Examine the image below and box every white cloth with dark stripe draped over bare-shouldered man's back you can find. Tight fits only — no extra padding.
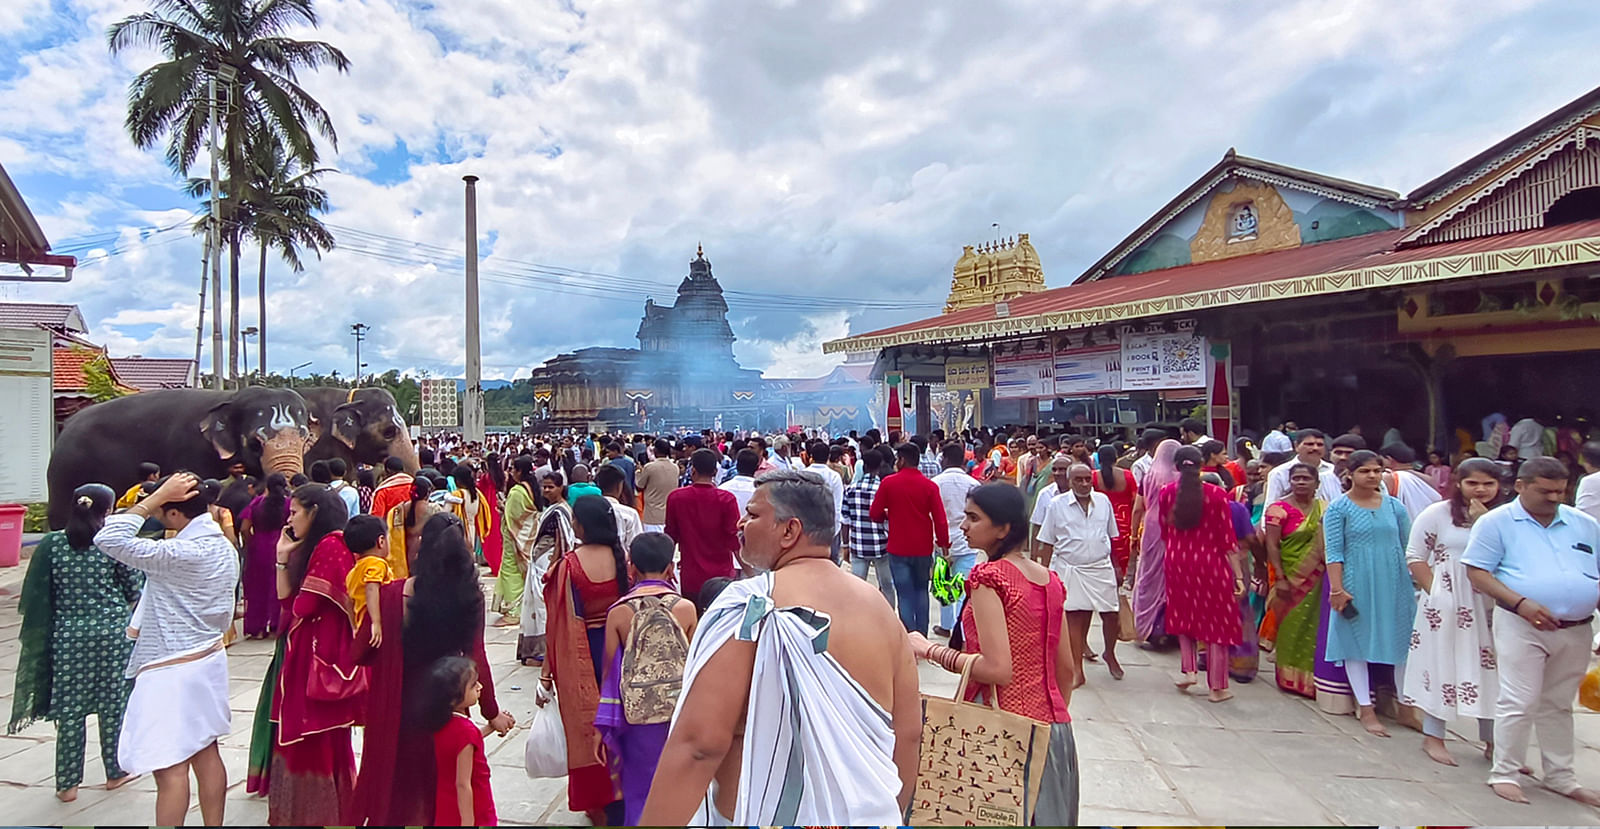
[672,573,904,826]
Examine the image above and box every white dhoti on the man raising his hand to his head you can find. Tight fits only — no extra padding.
[117,648,234,775]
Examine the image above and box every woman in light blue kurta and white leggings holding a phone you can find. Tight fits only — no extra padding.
[1323,450,1416,736]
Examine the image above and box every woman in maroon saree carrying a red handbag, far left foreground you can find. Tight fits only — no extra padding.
[267,483,366,826]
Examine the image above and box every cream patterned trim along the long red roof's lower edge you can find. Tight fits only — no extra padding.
[822,237,1600,354]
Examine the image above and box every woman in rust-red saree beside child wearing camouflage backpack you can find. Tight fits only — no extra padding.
[536,495,627,826]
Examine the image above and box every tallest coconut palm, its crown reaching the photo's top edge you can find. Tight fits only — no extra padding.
[107,0,350,388]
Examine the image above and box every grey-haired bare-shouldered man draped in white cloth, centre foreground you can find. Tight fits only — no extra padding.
[640,471,922,826]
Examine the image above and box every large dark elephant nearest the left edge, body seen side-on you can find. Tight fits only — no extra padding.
[46,386,314,530]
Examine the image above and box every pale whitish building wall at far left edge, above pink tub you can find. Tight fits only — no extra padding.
[0,328,56,504]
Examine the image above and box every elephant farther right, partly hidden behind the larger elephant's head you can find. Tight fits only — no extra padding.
[294,386,419,474]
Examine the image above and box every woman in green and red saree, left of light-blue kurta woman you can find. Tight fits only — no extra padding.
[1261,464,1326,699]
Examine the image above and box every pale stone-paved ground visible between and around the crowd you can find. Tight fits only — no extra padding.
[0,547,1600,826]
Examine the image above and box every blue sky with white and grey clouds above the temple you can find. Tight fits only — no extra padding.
[0,0,1600,384]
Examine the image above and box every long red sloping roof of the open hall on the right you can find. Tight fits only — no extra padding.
[834,219,1600,350]
